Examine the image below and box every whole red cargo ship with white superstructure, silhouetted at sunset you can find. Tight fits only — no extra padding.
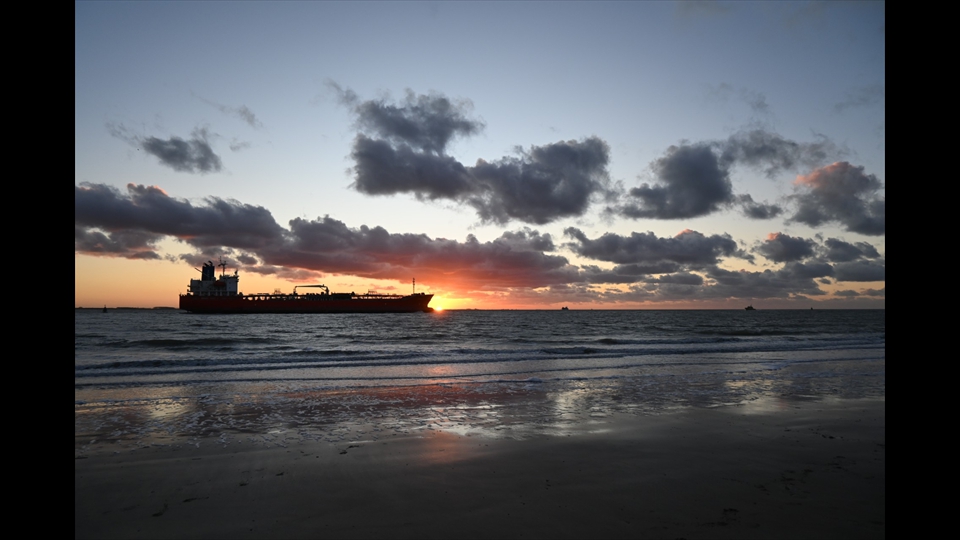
[180,260,433,313]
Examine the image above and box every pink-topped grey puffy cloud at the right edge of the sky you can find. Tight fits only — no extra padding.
[790,161,886,235]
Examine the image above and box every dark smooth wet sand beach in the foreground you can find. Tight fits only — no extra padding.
[74,400,886,539]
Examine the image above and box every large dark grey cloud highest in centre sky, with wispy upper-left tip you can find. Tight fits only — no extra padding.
[330,83,611,224]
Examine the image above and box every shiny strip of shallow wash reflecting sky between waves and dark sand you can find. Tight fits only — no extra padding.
[75,352,883,453]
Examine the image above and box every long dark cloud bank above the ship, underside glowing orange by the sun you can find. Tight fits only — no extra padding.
[74,184,580,290]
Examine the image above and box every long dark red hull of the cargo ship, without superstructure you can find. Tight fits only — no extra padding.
[180,294,433,313]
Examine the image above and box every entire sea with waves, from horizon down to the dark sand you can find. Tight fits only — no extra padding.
[74,309,886,455]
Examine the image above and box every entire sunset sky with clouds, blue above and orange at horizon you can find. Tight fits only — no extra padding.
[74,1,886,309]
